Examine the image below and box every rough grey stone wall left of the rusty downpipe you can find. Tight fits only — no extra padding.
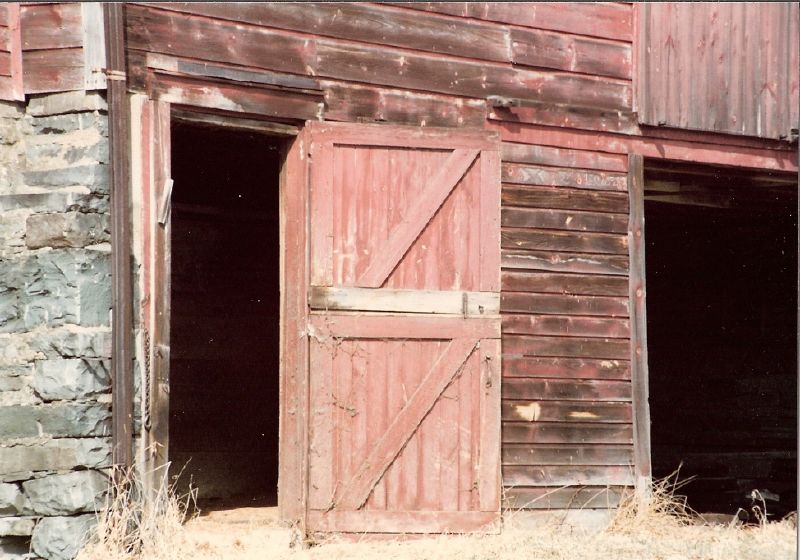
[0,92,111,560]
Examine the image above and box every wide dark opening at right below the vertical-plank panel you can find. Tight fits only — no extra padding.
[645,163,797,518]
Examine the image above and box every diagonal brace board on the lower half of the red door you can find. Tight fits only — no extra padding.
[334,338,480,510]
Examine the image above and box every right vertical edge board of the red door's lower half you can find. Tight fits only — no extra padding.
[478,339,501,511]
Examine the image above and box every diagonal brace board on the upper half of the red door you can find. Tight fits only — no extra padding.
[357,149,480,288]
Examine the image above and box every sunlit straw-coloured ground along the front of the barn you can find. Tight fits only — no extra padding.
[169,508,797,560]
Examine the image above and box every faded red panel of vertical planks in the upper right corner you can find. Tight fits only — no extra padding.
[637,2,800,138]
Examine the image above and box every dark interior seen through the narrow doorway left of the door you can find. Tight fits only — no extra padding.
[169,121,282,509]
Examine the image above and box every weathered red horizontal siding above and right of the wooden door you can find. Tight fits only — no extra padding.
[120,3,797,508]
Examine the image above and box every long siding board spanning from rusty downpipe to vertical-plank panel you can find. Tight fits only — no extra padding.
[128,6,632,110]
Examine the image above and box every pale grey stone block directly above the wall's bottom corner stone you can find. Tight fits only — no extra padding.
[22,470,108,515]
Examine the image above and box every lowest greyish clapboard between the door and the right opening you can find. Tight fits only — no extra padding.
[505,486,630,510]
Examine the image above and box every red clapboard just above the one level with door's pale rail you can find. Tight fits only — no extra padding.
[501,271,628,296]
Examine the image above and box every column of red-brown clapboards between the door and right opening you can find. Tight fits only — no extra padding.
[500,143,633,509]
